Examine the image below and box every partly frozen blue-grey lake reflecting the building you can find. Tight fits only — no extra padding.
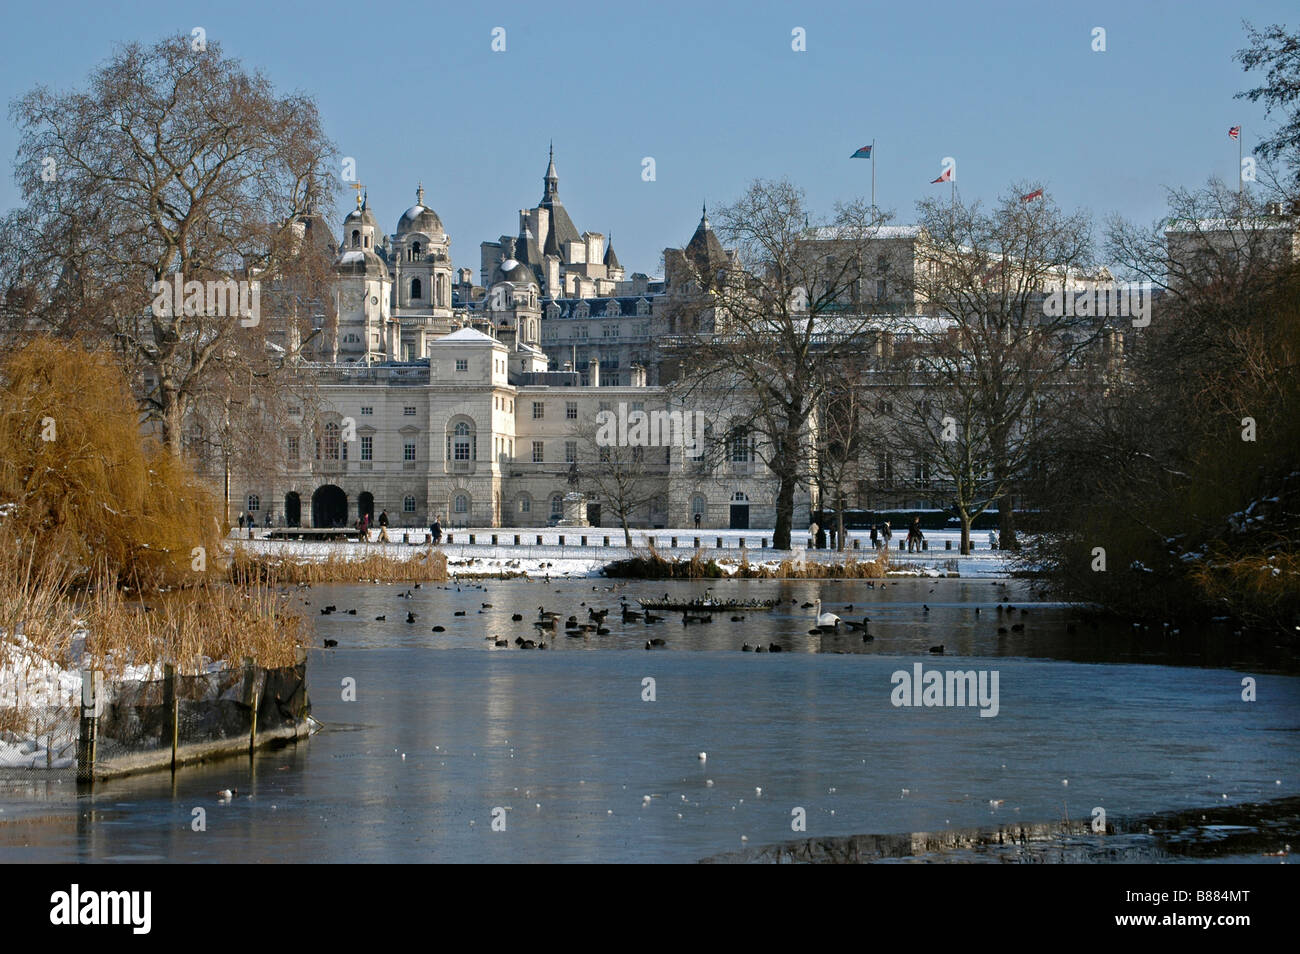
[0,580,1300,862]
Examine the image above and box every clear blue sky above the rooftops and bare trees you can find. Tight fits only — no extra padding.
[0,0,1300,276]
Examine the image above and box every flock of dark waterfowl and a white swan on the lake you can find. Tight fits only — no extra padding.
[304,581,1045,655]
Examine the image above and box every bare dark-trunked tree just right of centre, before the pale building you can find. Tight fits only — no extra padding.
[675,179,883,550]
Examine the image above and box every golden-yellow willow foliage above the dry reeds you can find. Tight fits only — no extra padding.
[0,338,221,589]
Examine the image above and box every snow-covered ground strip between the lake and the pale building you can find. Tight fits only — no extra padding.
[233,526,1010,577]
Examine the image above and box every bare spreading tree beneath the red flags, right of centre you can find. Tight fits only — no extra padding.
[897,186,1109,552]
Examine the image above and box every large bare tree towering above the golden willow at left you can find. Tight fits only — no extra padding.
[0,34,335,455]
